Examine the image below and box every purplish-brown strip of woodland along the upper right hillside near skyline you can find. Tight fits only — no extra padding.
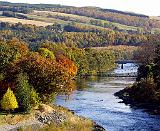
[53,7,160,29]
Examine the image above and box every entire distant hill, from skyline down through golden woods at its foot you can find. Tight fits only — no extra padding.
[0,2,160,49]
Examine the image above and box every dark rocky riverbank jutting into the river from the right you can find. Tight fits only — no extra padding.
[114,87,160,115]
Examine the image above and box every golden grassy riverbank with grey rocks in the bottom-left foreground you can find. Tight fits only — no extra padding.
[0,104,105,131]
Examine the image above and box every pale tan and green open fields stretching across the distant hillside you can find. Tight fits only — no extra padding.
[0,11,140,31]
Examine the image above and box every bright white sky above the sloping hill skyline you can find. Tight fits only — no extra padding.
[4,0,160,16]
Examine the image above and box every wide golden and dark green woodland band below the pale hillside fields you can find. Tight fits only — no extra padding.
[0,22,147,49]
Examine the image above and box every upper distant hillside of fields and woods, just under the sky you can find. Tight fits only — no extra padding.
[0,2,160,33]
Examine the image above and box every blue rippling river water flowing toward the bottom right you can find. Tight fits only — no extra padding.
[56,63,160,131]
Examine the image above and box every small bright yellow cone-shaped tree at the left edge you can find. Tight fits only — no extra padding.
[1,88,18,111]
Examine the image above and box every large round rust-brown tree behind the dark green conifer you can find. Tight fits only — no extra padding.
[17,52,68,94]
